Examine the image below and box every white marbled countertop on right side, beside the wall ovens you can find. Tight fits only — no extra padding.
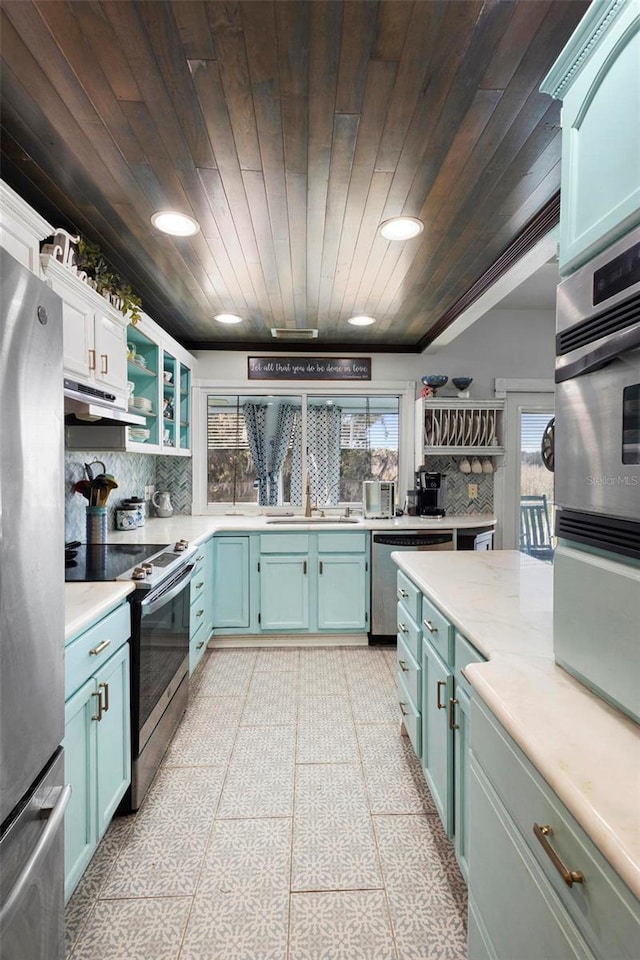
[392,550,640,897]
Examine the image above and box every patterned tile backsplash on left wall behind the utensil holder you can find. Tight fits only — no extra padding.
[64,450,191,543]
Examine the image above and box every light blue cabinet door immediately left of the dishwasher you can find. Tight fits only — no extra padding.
[318,553,368,630]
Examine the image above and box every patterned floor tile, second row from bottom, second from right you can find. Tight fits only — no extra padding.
[291,815,382,890]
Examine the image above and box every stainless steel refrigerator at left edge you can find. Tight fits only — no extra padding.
[0,250,70,960]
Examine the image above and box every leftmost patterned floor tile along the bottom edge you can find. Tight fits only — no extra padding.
[73,897,191,960]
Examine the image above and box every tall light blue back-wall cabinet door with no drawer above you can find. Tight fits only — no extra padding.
[211,535,251,630]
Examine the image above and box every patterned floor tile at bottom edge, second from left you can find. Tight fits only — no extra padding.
[178,887,289,960]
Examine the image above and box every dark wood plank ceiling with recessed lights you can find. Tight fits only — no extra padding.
[1,0,588,353]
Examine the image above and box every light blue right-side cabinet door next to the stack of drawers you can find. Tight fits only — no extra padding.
[422,639,453,837]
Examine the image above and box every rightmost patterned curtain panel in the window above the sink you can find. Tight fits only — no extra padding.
[307,406,342,506]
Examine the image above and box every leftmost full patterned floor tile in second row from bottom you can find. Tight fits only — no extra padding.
[100,820,209,899]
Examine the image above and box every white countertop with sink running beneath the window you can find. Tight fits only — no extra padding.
[104,513,496,543]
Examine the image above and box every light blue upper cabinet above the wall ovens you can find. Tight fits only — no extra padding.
[540,0,640,276]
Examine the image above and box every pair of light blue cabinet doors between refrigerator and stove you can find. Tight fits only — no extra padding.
[63,638,131,900]
